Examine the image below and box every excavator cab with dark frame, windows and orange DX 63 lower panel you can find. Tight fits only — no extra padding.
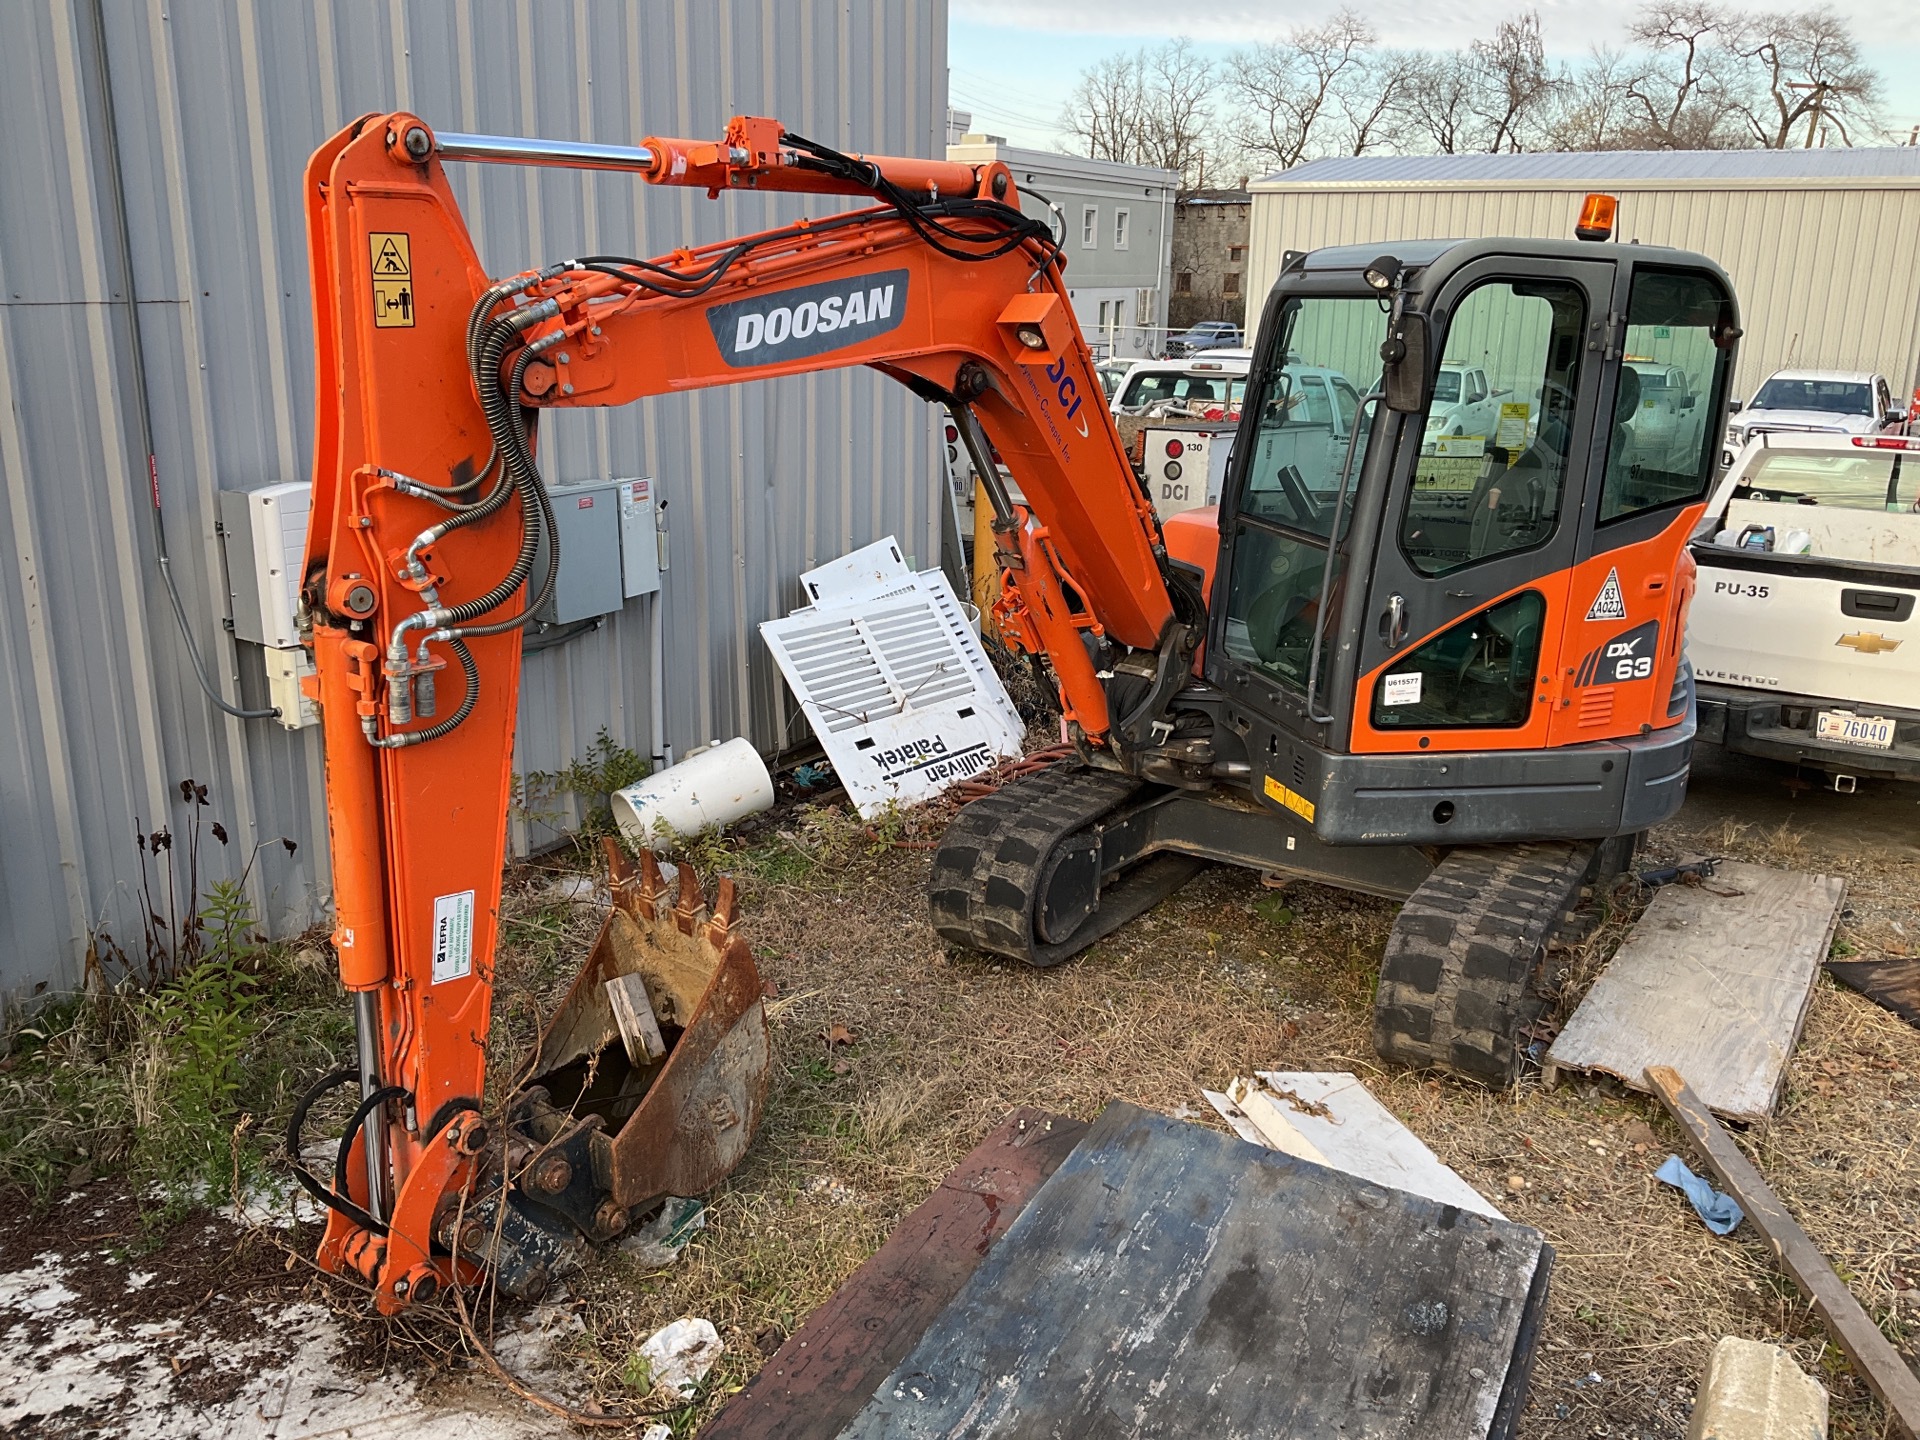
[1205,240,1738,847]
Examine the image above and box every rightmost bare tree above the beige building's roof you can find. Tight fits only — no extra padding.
[1732,6,1880,150]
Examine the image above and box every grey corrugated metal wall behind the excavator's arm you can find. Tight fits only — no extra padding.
[0,0,947,995]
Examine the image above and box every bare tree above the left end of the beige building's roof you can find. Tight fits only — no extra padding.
[1227,10,1375,169]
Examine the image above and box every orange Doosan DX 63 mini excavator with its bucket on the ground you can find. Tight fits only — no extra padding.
[290,113,1740,1309]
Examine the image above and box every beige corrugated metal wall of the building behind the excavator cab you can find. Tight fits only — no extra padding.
[1250,177,1920,407]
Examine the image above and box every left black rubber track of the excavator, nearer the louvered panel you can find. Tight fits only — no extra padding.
[927,764,1206,966]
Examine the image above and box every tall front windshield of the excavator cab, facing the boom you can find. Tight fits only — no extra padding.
[1225,296,1386,691]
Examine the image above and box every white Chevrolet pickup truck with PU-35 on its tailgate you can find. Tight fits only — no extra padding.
[1686,432,1920,793]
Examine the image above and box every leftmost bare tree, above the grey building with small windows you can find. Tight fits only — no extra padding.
[1060,38,1215,186]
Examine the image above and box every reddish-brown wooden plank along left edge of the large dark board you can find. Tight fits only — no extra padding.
[701,1108,1087,1440]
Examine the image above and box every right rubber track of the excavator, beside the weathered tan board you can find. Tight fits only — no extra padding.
[1373,841,1594,1085]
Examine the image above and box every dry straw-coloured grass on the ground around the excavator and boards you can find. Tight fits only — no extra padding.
[483,794,1920,1436]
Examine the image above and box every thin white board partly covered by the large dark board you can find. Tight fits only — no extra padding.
[1258,1069,1505,1219]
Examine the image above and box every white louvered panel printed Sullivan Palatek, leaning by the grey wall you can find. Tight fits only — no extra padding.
[760,570,1021,818]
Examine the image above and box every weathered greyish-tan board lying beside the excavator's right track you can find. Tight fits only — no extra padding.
[1546,860,1847,1119]
